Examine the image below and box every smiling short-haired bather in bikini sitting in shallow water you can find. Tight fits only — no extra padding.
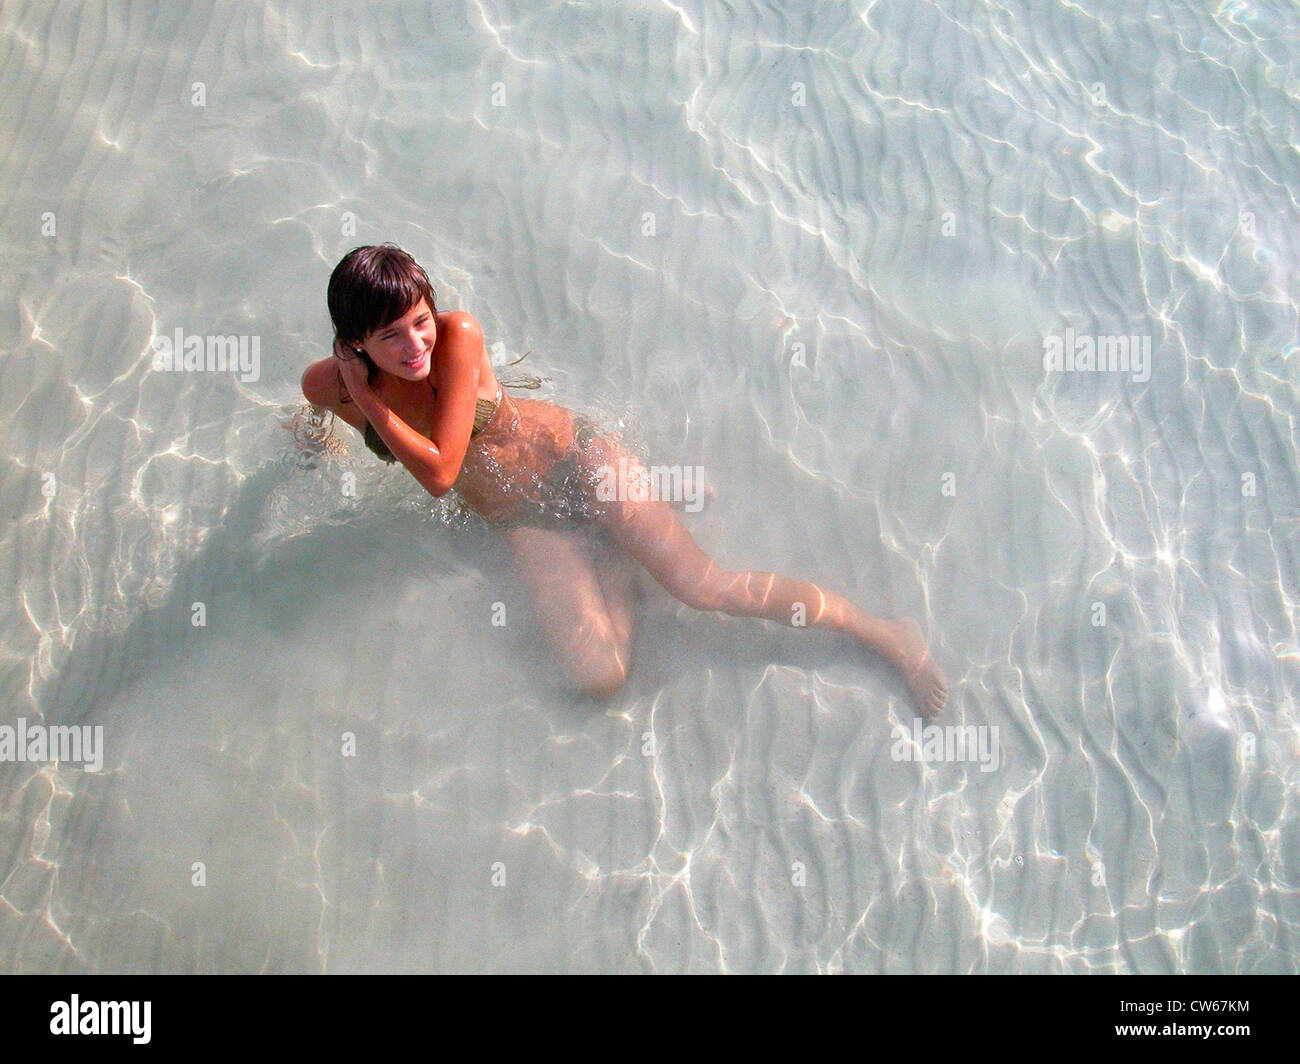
[303,245,948,717]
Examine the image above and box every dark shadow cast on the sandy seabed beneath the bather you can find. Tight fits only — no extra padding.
[38,439,905,727]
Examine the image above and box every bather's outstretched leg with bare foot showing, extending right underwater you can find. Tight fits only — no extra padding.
[603,465,948,717]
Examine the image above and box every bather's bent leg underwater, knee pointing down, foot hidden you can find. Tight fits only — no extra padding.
[506,528,633,698]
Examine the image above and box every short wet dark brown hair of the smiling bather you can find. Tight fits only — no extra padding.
[326,243,438,381]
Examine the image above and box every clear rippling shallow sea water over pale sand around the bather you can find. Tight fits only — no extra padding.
[0,0,1300,973]
